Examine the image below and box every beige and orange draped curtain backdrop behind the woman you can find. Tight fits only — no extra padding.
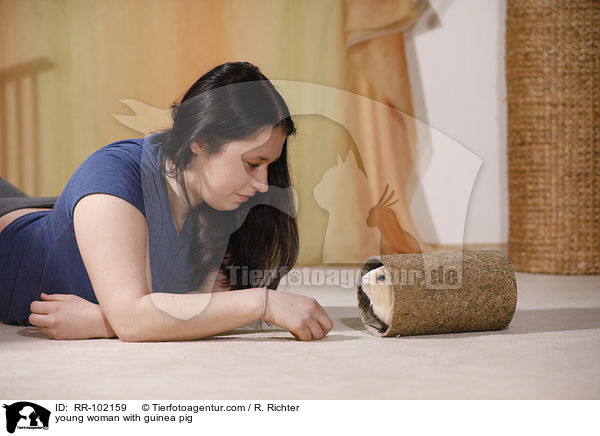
[0,0,422,265]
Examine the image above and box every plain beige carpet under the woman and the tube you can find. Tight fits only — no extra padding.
[0,266,600,399]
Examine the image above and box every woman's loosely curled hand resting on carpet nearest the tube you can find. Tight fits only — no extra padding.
[264,289,333,341]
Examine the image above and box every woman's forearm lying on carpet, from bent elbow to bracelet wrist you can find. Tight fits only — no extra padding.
[120,288,265,342]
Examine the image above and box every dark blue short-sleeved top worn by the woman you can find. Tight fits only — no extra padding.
[0,135,200,325]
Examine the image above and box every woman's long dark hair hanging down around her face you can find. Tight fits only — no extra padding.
[153,62,299,290]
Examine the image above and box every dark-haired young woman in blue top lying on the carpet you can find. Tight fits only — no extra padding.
[0,62,333,341]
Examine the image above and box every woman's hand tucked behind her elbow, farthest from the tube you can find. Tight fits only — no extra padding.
[29,293,116,339]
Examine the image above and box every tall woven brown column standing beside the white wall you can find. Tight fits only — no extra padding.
[505,0,600,274]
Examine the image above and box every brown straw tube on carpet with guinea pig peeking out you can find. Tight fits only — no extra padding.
[357,250,517,337]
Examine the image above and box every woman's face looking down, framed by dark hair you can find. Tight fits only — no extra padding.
[186,126,286,210]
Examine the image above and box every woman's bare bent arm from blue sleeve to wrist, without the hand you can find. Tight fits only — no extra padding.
[73,194,265,341]
